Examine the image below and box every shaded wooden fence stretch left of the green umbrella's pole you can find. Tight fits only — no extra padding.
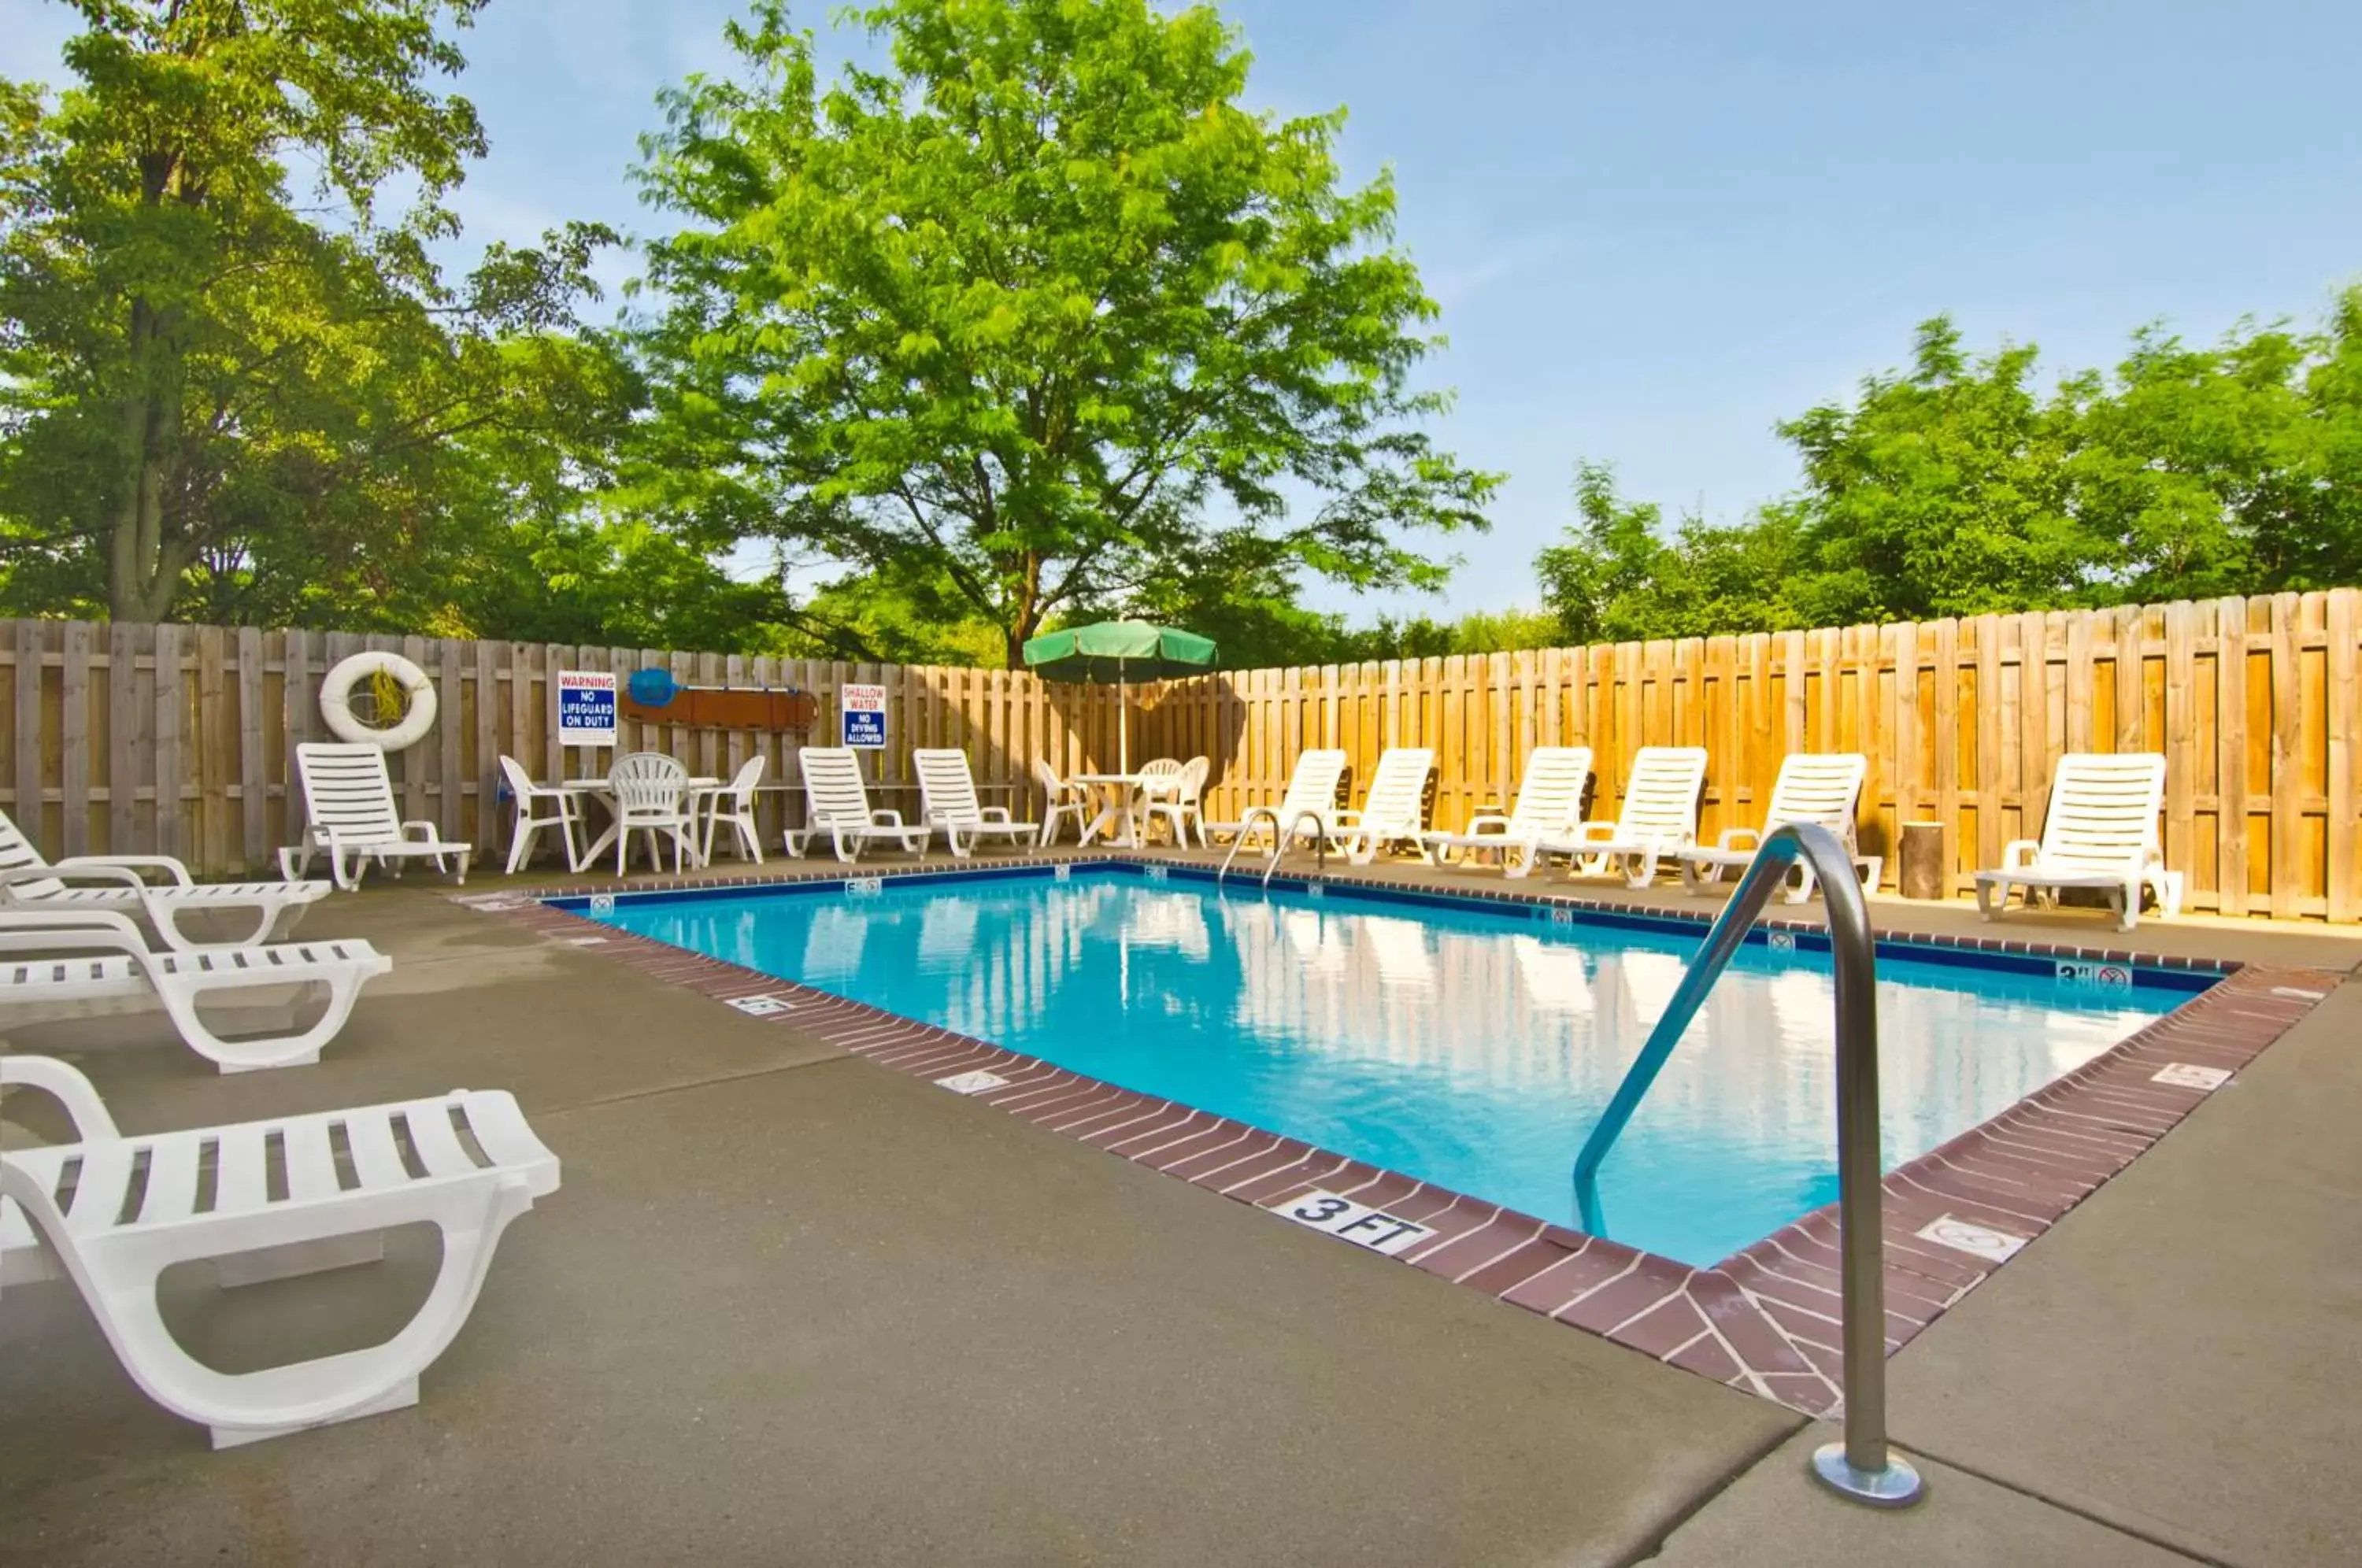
[0,621,1138,876]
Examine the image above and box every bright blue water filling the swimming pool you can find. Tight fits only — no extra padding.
[595,869,2187,1266]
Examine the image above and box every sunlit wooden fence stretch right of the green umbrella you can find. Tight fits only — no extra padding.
[1131,588,2362,921]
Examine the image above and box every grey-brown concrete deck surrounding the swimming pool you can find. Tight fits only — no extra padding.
[0,850,2362,1563]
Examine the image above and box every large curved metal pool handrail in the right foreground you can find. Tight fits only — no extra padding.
[1575,822,1925,1509]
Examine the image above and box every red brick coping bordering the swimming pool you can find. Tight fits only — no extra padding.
[454,855,2343,1415]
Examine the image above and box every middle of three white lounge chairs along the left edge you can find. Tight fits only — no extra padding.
[0,909,394,1072]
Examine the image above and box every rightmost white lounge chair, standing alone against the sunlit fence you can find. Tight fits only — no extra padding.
[1977,751,2182,930]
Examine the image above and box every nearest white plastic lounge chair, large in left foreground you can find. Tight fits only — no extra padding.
[0,1056,557,1448]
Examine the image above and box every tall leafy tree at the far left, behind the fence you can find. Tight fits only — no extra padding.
[0,0,621,623]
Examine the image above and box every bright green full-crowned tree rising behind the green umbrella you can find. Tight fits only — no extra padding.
[640,0,1495,664]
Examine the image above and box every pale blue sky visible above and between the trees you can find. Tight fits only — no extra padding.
[0,0,2362,614]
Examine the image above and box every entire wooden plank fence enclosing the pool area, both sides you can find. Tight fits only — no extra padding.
[0,590,2362,921]
